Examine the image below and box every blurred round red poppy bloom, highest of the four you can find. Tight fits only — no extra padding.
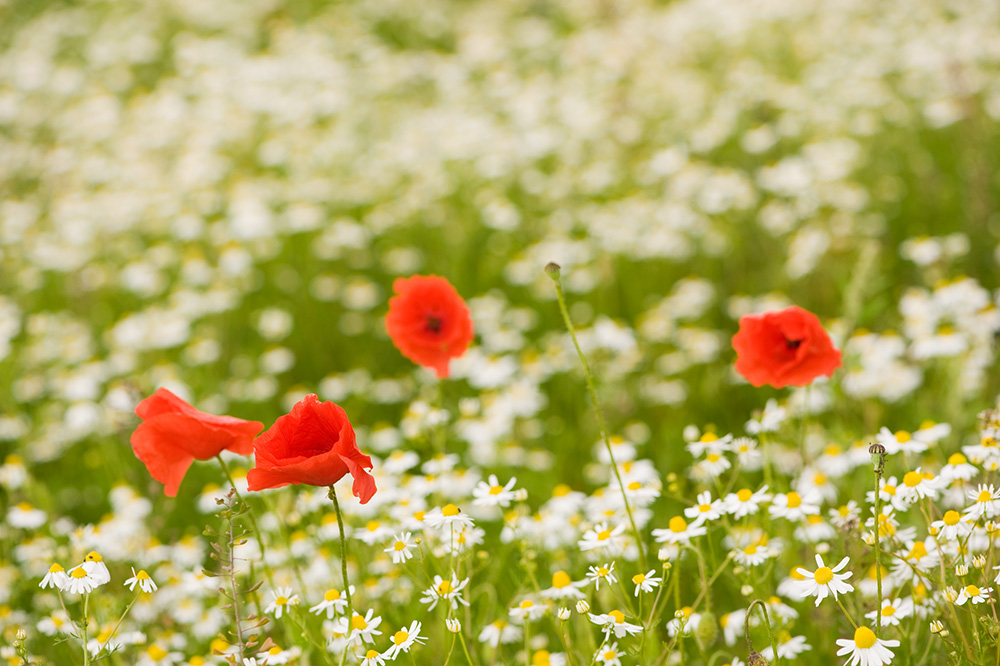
[385,275,472,379]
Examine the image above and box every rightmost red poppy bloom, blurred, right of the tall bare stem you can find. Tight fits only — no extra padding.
[733,306,841,388]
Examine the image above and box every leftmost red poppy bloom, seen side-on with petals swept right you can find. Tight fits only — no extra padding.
[131,388,264,497]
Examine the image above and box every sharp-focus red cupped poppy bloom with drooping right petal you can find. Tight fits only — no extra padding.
[247,393,375,504]
